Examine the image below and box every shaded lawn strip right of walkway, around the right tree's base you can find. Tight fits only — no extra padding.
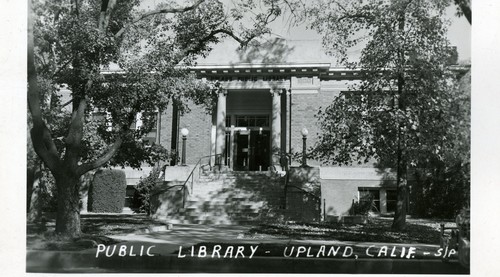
[249,218,440,244]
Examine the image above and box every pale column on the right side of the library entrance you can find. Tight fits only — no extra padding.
[271,88,283,166]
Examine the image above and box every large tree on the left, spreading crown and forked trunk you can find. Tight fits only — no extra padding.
[28,0,290,237]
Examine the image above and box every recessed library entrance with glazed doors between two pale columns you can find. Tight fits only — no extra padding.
[212,86,286,171]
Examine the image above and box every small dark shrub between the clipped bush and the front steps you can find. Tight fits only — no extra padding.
[132,166,165,215]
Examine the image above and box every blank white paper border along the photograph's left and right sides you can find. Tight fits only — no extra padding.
[0,0,500,276]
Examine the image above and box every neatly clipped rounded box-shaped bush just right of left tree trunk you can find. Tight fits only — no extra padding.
[88,169,127,213]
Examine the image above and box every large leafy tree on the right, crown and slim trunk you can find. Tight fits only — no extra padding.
[309,0,469,230]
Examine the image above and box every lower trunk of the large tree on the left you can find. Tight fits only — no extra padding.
[55,175,81,238]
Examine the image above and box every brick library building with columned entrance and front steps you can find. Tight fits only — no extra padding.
[109,38,464,222]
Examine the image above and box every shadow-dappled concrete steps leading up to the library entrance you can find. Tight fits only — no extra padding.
[162,169,283,225]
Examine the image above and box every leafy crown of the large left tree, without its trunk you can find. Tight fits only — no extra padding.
[33,0,292,170]
